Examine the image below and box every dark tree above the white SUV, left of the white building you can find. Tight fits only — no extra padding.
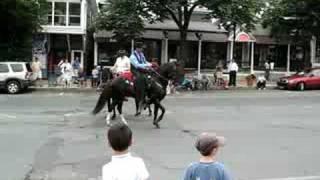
[0,0,47,61]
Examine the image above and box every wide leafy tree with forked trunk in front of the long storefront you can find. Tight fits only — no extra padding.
[97,0,262,60]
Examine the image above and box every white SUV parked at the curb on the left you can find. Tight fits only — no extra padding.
[0,62,34,94]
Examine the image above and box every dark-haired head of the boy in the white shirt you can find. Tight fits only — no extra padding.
[108,123,132,151]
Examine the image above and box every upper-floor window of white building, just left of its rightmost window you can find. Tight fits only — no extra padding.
[54,2,67,26]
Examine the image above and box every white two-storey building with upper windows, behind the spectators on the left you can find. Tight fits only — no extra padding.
[33,0,89,78]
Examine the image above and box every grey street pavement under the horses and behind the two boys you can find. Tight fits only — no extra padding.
[0,90,320,180]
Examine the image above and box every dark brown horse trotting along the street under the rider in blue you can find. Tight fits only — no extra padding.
[92,63,177,127]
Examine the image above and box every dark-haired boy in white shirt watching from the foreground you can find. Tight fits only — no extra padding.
[102,123,149,180]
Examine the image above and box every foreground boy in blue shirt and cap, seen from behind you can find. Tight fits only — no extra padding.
[183,133,232,180]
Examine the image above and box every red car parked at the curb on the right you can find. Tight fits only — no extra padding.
[277,68,320,91]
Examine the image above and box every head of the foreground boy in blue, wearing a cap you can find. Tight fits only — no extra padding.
[195,133,225,156]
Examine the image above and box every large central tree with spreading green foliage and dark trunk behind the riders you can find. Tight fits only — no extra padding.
[95,0,260,59]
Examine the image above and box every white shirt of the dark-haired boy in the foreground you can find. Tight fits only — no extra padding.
[102,153,149,180]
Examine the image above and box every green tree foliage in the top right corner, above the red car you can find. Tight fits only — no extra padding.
[264,0,320,41]
